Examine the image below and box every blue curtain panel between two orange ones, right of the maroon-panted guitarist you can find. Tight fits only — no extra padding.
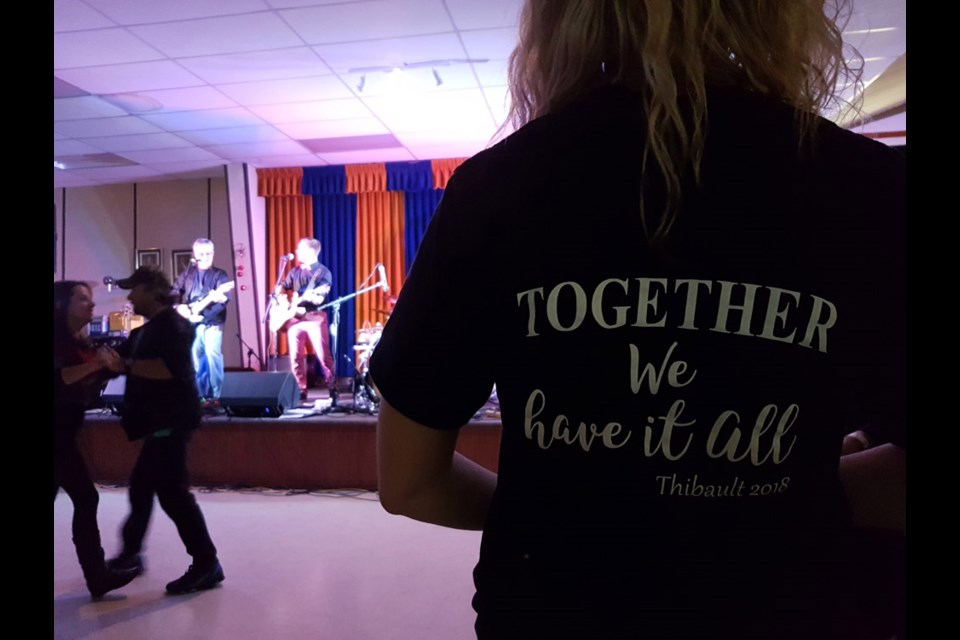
[314,192,357,377]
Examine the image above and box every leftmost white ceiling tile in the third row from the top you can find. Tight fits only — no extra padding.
[57,60,203,93]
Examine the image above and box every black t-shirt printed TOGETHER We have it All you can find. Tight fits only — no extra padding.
[371,88,906,637]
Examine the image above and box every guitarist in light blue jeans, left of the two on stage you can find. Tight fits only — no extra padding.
[171,238,234,408]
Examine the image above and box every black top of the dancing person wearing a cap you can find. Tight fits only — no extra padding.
[118,307,200,440]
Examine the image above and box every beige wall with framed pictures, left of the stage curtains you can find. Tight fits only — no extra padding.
[53,178,244,367]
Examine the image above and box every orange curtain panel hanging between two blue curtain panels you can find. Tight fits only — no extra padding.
[356,191,405,336]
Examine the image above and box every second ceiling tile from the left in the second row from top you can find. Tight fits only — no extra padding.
[130,13,303,58]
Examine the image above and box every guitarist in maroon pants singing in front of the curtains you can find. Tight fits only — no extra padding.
[270,238,336,400]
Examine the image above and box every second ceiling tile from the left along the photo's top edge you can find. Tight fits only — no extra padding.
[87,0,269,24]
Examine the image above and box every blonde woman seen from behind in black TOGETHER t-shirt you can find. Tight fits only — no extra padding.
[370,0,906,639]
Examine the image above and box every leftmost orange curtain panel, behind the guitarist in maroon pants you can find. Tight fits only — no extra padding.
[257,168,313,354]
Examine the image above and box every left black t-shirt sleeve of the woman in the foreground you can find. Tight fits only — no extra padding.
[370,167,494,429]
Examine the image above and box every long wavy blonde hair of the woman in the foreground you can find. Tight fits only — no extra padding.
[508,0,860,242]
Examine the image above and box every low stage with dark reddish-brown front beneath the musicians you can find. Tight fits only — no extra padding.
[79,391,501,490]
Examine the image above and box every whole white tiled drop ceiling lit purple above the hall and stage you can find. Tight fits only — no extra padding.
[53,0,906,187]
